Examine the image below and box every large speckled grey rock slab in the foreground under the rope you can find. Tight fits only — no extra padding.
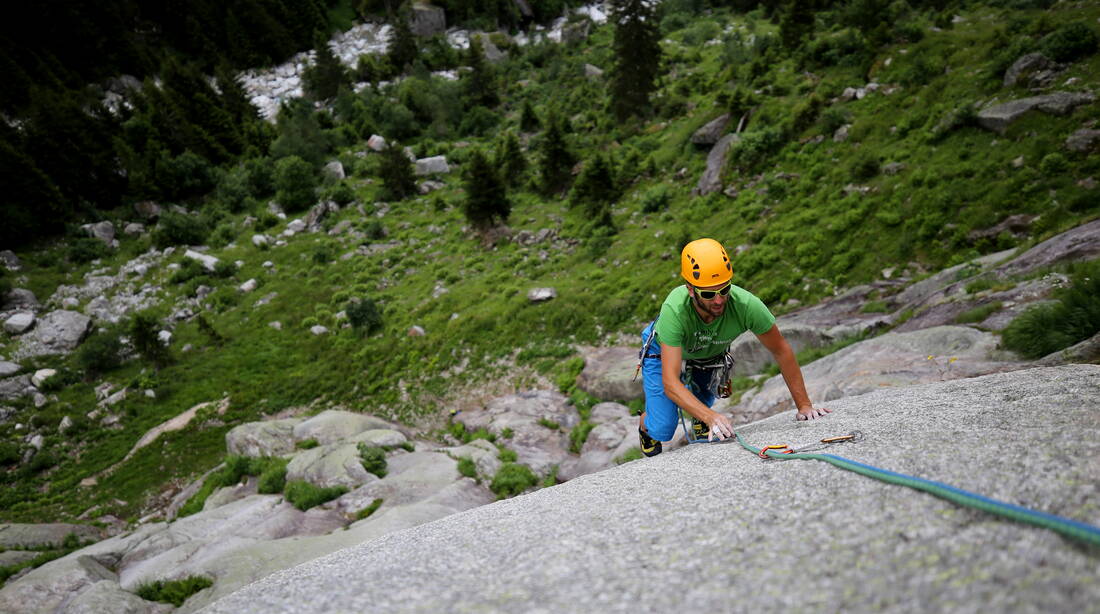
[198,365,1100,614]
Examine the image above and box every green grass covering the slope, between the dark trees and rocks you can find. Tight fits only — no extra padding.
[0,4,1100,520]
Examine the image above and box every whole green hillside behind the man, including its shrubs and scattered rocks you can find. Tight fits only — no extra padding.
[0,2,1100,554]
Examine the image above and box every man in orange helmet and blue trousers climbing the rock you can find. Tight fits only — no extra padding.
[638,239,829,457]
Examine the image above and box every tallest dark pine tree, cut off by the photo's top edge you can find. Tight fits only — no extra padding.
[611,0,661,120]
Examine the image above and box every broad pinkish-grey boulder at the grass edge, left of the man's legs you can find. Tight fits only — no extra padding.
[454,391,581,475]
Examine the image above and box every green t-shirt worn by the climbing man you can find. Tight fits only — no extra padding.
[657,286,776,359]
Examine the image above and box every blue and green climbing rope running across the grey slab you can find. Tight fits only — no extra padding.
[734,431,1100,546]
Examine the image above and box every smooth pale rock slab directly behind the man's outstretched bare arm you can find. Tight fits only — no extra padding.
[735,326,1021,423]
